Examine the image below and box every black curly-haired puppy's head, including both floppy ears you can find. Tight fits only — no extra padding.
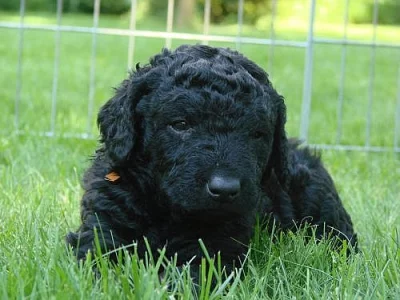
[98,45,288,215]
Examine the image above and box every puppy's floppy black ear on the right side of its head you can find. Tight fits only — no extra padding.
[266,92,290,190]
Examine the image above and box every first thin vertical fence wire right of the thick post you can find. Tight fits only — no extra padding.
[336,0,349,145]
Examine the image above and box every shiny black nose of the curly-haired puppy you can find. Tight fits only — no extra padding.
[207,175,240,202]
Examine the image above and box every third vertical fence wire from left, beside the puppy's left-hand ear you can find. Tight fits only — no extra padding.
[86,0,100,136]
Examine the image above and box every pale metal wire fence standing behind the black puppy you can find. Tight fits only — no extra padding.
[0,0,400,152]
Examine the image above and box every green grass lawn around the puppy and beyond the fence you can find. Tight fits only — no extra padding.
[0,10,400,299]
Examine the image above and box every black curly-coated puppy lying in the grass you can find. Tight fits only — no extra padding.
[67,45,356,274]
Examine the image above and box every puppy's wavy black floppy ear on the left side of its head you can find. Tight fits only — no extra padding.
[97,80,136,164]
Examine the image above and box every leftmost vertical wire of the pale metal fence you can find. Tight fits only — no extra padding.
[14,0,25,131]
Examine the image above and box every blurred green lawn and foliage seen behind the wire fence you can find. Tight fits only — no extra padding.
[0,0,400,147]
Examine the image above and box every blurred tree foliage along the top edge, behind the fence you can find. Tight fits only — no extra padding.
[0,0,400,27]
